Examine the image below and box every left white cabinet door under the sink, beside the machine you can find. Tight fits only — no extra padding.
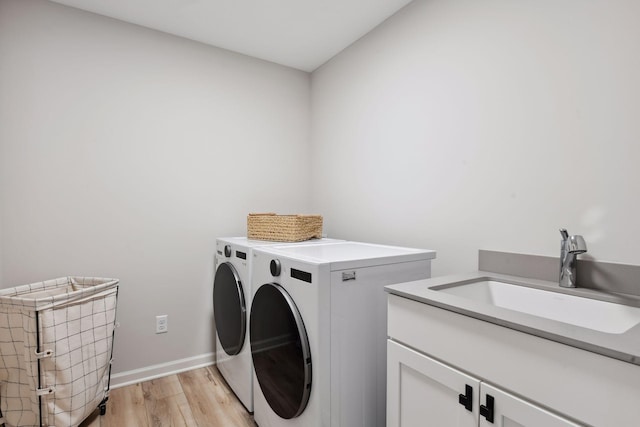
[387,340,480,427]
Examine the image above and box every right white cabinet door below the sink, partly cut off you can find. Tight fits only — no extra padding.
[479,383,580,427]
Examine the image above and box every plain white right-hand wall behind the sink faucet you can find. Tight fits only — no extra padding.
[311,0,640,275]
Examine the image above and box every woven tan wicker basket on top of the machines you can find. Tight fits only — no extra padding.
[247,213,322,242]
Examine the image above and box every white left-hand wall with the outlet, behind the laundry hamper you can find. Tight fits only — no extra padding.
[0,0,310,374]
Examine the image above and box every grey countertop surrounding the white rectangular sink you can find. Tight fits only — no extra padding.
[385,271,640,365]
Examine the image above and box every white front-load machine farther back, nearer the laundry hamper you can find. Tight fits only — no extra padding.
[213,237,343,412]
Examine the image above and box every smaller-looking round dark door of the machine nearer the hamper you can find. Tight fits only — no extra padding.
[213,262,247,356]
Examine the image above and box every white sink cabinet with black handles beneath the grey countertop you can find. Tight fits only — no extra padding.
[387,295,640,427]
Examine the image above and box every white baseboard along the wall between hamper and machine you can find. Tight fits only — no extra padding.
[110,353,215,389]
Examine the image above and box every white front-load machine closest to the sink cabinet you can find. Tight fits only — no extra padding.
[249,242,436,427]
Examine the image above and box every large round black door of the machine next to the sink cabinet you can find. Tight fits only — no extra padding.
[249,283,311,419]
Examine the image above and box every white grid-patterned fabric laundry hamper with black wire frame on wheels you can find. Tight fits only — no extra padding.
[0,277,119,427]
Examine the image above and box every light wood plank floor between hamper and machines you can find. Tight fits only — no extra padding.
[80,366,256,427]
